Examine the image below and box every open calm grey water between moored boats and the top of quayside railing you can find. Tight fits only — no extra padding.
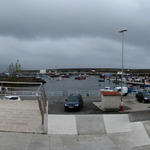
[44,76,123,95]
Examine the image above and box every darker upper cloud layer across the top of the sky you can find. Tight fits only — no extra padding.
[0,0,150,38]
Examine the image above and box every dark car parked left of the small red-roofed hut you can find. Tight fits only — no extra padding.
[64,94,83,111]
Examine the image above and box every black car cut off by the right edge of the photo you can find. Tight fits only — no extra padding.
[136,91,150,103]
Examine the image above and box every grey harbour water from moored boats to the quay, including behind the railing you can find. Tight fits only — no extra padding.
[44,76,128,96]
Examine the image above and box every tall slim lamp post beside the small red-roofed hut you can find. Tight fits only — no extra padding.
[119,29,127,109]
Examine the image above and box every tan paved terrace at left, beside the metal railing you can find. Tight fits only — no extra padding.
[0,100,43,133]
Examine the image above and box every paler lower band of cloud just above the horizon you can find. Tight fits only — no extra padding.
[0,37,150,69]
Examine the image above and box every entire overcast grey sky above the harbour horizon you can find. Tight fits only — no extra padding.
[0,0,150,69]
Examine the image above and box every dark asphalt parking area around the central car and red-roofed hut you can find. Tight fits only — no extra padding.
[48,96,150,114]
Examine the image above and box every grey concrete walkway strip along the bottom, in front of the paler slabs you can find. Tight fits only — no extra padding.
[0,132,150,150]
